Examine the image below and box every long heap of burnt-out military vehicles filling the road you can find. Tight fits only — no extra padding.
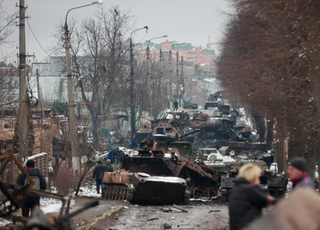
[98,99,287,204]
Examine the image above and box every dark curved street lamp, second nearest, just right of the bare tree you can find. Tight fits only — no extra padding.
[130,26,148,139]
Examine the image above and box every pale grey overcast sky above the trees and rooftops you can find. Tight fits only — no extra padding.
[1,0,232,61]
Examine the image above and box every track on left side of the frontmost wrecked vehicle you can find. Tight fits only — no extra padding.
[101,186,133,201]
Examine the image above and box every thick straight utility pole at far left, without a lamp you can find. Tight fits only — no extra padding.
[18,0,28,160]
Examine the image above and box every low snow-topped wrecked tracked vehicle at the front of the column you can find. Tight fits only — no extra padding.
[101,170,190,204]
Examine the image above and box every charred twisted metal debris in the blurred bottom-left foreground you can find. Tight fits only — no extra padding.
[0,153,99,230]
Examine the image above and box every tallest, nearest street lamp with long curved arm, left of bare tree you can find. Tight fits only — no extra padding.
[64,0,103,173]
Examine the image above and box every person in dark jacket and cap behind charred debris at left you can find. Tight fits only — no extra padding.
[17,160,47,217]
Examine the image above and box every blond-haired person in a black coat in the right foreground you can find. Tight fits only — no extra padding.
[229,164,274,230]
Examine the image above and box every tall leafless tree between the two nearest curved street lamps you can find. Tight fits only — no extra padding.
[73,7,130,149]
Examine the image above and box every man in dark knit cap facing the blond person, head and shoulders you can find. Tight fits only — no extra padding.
[287,157,315,189]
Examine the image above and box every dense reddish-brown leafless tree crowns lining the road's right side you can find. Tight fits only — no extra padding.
[218,0,320,180]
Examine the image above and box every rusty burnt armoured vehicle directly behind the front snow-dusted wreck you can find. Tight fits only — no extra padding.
[122,134,219,197]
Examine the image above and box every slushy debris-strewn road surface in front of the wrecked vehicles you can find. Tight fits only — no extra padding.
[63,197,229,230]
